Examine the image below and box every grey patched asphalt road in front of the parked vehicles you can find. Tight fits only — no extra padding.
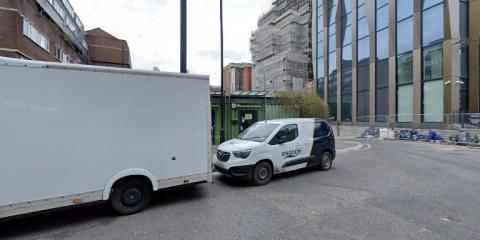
[0,141,480,240]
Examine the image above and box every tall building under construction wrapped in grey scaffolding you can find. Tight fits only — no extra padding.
[250,0,313,91]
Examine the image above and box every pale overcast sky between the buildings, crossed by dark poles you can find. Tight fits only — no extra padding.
[70,0,272,86]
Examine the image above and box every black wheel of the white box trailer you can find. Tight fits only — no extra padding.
[110,179,152,215]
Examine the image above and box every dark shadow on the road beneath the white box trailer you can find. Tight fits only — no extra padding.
[0,185,206,239]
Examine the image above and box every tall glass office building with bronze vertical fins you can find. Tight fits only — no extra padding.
[312,0,480,123]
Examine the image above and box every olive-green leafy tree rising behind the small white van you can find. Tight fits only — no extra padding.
[277,91,330,119]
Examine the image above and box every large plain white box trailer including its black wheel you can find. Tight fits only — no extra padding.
[0,58,212,219]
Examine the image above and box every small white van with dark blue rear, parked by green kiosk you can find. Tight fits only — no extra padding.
[214,119,335,185]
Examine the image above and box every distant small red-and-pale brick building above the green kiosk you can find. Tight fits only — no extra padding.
[223,63,252,95]
